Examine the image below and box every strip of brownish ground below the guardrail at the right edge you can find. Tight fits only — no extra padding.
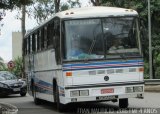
[144,85,160,92]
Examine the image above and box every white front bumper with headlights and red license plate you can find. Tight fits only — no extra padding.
[62,83,144,104]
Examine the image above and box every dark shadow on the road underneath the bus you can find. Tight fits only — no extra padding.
[20,101,119,114]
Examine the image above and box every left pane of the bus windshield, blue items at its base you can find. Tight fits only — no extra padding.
[64,19,104,60]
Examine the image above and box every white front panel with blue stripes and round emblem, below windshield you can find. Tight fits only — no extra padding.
[63,60,143,85]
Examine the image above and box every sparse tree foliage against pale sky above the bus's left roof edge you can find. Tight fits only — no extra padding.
[30,0,81,24]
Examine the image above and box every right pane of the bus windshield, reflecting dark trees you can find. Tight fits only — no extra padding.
[103,17,140,58]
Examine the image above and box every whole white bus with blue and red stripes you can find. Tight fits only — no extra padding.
[23,7,144,110]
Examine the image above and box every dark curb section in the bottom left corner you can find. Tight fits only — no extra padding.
[0,102,18,114]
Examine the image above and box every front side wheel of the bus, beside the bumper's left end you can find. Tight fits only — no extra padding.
[55,85,64,112]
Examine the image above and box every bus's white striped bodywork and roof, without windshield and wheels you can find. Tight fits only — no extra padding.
[23,7,144,108]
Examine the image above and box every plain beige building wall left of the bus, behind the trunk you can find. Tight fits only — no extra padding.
[12,32,22,60]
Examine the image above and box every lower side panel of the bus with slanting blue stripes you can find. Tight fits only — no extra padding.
[26,49,63,102]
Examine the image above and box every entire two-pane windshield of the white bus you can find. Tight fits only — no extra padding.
[64,17,140,61]
